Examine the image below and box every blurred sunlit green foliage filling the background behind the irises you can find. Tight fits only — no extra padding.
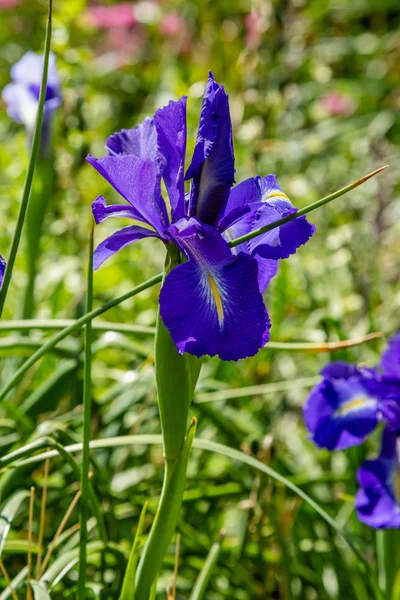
[0,0,400,600]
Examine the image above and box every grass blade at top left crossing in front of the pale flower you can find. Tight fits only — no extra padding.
[0,0,53,318]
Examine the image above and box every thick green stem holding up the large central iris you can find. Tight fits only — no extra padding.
[135,245,201,600]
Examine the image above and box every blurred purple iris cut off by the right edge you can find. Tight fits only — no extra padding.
[304,332,400,528]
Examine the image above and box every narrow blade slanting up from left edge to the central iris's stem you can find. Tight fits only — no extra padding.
[0,273,162,402]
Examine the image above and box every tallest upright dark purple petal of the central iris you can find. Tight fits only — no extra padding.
[185,73,235,224]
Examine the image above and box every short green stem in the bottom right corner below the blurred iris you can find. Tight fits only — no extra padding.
[377,529,400,600]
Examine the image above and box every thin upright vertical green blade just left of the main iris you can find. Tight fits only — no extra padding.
[78,225,93,600]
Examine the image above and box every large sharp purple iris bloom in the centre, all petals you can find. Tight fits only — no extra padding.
[87,73,315,360]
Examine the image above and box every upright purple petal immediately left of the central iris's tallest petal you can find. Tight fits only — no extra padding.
[154,96,187,221]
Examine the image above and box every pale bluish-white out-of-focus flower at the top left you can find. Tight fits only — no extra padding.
[2,52,61,148]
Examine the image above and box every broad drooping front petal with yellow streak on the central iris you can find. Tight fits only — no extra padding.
[160,218,270,360]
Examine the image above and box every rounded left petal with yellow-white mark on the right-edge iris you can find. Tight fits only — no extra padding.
[304,363,378,450]
